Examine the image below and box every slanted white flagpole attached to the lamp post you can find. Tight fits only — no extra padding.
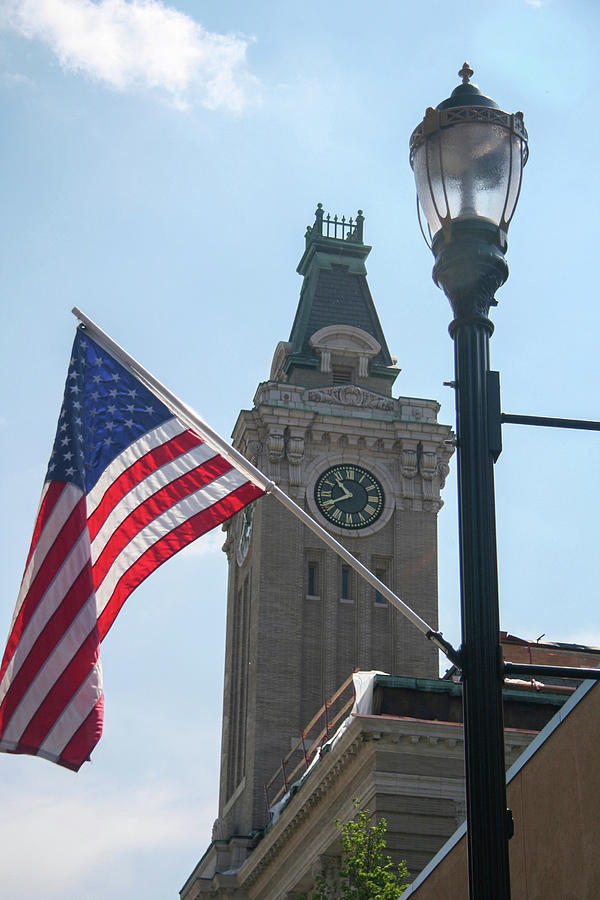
[71,306,460,665]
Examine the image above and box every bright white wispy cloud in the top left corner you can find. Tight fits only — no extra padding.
[0,0,258,112]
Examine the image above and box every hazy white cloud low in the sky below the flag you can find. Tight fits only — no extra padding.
[0,776,214,900]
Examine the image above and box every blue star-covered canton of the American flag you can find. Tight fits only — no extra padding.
[46,331,173,494]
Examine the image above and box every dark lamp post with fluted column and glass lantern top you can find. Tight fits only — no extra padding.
[410,63,528,900]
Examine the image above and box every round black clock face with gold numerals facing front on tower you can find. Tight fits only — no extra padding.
[315,464,385,530]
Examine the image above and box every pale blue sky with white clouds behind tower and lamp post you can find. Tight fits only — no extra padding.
[0,0,600,900]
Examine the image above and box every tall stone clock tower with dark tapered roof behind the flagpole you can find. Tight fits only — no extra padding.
[213,204,452,852]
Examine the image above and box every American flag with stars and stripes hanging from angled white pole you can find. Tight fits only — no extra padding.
[0,330,264,771]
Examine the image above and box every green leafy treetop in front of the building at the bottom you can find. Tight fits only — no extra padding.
[311,800,408,900]
